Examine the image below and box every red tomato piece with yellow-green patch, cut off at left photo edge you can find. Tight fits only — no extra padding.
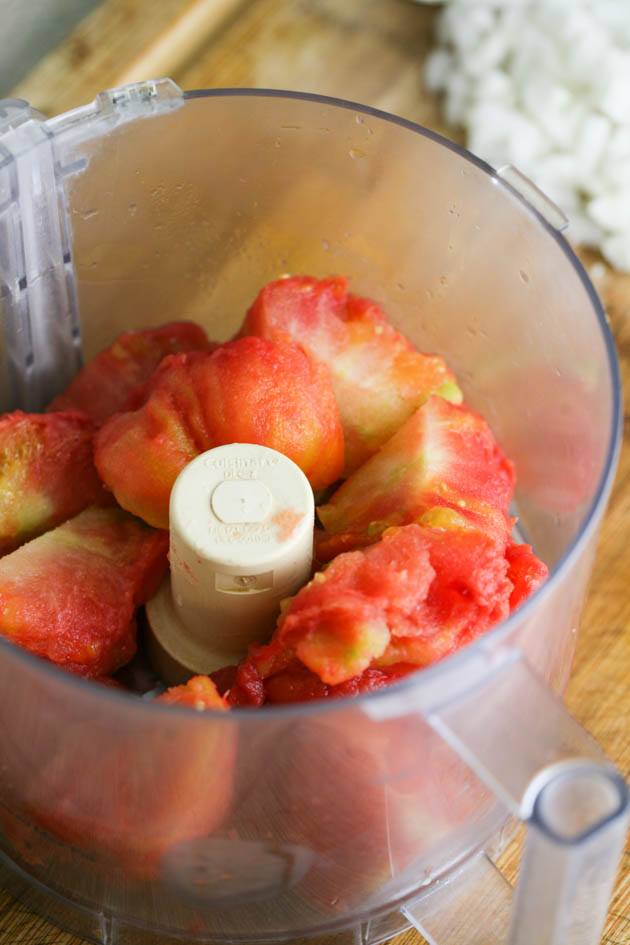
[0,410,111,555]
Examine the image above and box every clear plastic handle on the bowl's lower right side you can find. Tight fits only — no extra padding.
[403,654,629,945]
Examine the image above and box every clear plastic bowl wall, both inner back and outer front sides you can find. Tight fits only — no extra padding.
[0,93,616,943]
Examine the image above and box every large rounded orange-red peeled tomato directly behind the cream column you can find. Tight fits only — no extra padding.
[95,338,343,528]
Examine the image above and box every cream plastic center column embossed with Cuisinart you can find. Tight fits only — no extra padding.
[146,443,315,685]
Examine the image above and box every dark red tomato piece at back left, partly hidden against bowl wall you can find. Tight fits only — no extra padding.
[48,322,214,426]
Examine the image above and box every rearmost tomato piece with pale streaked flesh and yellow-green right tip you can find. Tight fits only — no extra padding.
[241,276,462,475]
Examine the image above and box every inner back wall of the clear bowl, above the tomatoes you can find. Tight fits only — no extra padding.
[66,95,611,559]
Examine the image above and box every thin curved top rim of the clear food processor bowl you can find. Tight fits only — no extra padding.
[0,88,623,724]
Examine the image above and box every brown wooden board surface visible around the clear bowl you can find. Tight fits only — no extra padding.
[0,0,630,945]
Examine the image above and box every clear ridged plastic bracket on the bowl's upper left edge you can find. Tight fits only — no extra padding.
[0,79,184,410]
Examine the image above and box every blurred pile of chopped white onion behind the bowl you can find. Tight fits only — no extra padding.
[425,0,630,270]
